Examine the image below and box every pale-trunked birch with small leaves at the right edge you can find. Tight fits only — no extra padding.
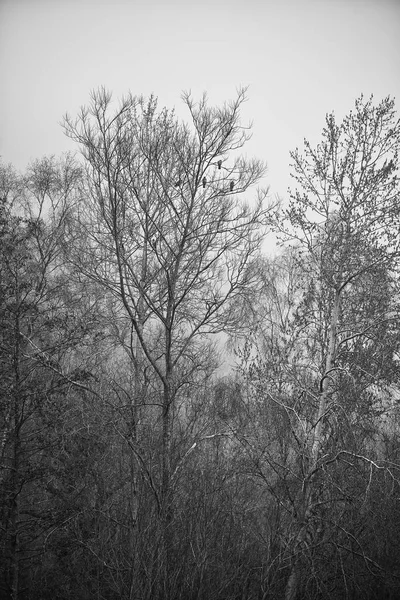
[242,97,400,600]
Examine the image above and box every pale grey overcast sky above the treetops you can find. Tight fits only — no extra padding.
[0,0,400,197]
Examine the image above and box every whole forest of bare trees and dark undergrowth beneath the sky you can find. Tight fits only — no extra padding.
[0,88,400,600]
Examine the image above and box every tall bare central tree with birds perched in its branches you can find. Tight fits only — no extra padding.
[64,89,268,598]
